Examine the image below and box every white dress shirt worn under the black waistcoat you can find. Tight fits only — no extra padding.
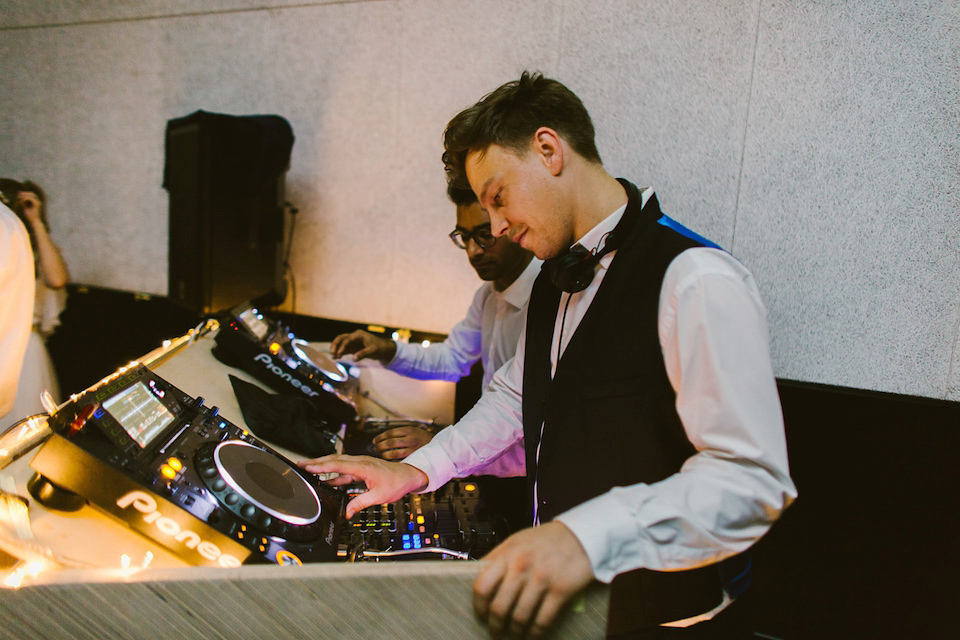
[405,189,796,582]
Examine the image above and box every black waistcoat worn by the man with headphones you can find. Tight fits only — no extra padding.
[523,180,740,635]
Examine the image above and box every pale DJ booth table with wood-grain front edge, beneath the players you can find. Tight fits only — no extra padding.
[0,334,607,640]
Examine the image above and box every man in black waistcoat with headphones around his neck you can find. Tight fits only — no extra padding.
[302,73,796,638]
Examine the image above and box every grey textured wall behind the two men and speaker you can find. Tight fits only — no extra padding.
[0,0,960,400]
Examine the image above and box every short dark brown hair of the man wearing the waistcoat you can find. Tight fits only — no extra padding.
[443,71,600,188]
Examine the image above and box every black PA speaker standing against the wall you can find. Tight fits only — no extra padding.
[163,111,294,314]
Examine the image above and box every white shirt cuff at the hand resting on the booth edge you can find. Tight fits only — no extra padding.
[555,495,637,583]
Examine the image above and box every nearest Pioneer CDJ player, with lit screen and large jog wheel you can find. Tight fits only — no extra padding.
[30,365,347,567]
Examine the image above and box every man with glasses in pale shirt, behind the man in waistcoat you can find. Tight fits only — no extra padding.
[330,186,541,462]
